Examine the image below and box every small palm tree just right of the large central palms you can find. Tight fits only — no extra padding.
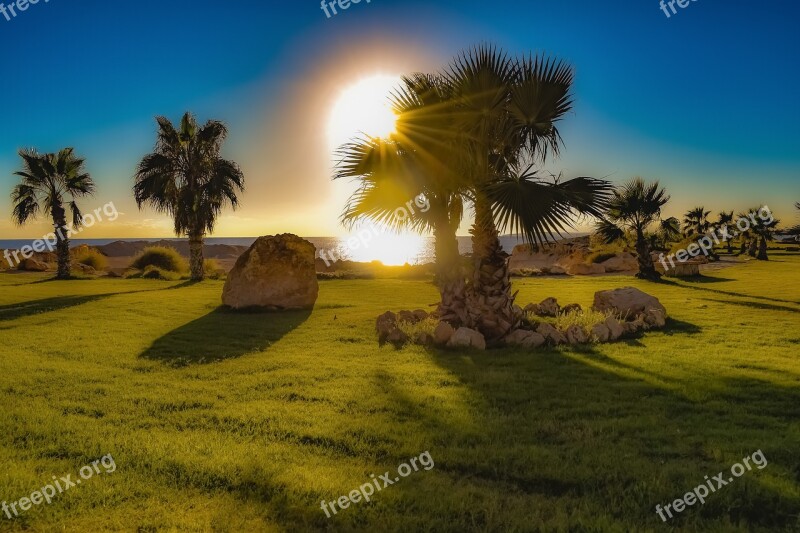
[596,178,670,281]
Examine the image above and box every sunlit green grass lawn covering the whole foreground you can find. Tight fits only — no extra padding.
[0,252,800,532]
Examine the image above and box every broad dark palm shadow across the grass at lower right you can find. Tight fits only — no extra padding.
[428,350,800,531]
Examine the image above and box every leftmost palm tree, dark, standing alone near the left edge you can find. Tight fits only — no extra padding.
[11,148,95,279]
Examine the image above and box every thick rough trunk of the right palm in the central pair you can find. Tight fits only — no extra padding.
[469,194,522,341]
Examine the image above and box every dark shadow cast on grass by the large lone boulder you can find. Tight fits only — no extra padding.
[139,306,311,368]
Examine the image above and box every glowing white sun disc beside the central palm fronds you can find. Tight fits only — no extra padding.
[328,75,401,148]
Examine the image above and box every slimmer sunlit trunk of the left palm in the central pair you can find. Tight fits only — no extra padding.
[433,220,469,328]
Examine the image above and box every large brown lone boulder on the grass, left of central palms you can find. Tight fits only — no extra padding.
[222,233,319,310]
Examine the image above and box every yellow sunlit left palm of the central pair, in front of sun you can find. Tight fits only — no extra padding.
[334,74,469,325]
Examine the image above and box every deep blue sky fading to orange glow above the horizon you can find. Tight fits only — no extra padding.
[0,0,800,239]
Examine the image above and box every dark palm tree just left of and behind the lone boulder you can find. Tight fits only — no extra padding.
[133,113,244,281]
